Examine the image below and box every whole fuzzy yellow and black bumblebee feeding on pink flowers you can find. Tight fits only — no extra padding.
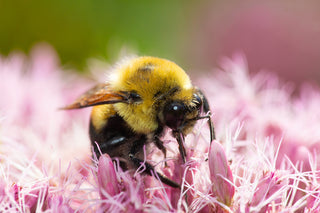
[64,57,215,188]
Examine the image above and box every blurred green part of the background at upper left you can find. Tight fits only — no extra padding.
[0,0,191,69]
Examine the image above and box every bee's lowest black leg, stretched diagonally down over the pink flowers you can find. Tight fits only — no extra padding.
[129,154,181,189]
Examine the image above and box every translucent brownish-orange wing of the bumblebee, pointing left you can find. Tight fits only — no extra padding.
[61,83,128,109]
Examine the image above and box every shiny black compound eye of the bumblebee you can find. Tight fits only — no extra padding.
[163,102,186,130]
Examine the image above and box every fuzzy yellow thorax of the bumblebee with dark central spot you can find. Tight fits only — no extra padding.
[110,57,193,134]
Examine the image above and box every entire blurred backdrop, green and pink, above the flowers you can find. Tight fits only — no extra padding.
[0,0,320,84]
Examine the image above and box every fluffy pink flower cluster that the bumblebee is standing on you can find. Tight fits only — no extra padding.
[0,46,320,212]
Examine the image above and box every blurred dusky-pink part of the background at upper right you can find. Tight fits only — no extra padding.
[190,0,320,84]
